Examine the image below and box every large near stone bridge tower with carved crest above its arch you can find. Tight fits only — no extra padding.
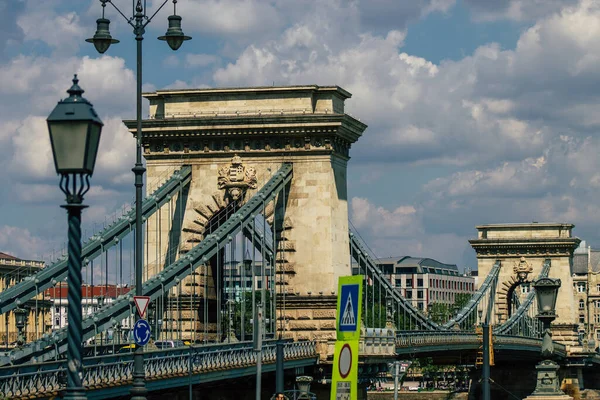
[126,85,366,350]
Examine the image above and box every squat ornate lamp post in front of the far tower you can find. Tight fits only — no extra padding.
[527,278,571,400]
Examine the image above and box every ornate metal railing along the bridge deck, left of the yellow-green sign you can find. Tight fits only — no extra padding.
[0,341,317,399]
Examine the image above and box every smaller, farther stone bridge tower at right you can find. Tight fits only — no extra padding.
[469,222,580,344]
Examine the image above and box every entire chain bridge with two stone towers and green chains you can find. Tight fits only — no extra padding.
[0,86,599,398]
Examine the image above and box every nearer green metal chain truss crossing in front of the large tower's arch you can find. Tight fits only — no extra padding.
[10,163,293,364]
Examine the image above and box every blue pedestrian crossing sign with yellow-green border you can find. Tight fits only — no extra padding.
[337,275,363,340]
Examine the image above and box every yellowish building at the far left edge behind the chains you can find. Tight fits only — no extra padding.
[0,252,51,347]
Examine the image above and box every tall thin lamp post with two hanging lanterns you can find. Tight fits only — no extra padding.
[86,0,191,400]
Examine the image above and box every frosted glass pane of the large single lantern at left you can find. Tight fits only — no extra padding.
[50,121,88,173]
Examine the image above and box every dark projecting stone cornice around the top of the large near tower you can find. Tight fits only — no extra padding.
[124,114,366,159]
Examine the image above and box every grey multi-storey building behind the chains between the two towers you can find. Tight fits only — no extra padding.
[364,256,475,311]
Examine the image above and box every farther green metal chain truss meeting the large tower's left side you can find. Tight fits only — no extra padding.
[0,166,192,314]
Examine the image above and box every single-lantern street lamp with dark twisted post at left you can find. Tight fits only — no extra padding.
[47,75,104,399]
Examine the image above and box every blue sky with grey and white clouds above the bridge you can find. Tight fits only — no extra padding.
[0,0,600,267]
